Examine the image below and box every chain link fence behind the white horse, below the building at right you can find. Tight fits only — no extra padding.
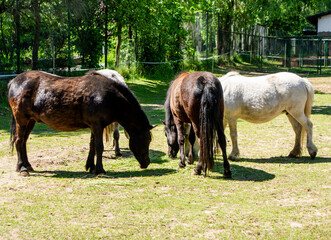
[192,27,331,74]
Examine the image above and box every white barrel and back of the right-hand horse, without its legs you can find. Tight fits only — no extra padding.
[220,72,308,123]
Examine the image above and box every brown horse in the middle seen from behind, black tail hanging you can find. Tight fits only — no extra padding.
[164,72,231,177]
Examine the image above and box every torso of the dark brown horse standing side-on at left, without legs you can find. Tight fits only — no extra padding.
[8,71,123,131]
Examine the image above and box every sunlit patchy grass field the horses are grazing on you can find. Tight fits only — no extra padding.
[0,71,331,239]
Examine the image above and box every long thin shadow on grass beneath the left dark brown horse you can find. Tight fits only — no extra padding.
[31,168,177,179]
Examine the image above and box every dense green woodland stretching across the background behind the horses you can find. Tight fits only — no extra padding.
[0,0,331,73]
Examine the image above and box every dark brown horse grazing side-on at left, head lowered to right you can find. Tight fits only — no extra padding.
[8,71,152,175]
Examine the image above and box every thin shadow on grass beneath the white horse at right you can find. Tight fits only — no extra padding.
[231,156,331,164]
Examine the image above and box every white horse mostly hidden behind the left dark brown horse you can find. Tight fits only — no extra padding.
[96,69,129,157]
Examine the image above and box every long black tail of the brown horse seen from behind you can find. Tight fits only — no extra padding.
[198,77,220,175]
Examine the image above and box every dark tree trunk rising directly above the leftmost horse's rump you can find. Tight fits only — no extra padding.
[32,0,41,70]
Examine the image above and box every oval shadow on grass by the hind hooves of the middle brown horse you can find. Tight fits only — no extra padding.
[212,162,275,182]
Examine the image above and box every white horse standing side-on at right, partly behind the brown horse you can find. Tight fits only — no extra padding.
[219,72,317,160]
